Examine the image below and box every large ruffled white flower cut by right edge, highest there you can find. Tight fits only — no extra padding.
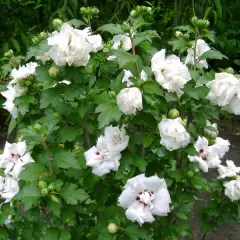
[207,72,240,115]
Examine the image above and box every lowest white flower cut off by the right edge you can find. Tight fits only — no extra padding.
[224,176,240,201]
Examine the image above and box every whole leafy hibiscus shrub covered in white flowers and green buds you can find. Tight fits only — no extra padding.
[0,6,240,240]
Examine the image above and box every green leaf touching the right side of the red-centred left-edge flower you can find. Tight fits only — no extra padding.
[20,163,47,182]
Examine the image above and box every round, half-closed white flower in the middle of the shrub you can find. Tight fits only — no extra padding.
[117,87,143,115]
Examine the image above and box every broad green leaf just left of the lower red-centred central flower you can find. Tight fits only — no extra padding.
[53,148,80,169]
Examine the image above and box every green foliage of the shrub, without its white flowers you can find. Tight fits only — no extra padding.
[0,1,239,240]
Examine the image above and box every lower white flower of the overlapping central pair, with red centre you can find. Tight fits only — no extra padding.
[84,136,121,177]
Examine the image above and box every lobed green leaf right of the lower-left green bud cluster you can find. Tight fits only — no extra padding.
[60,183,88,205]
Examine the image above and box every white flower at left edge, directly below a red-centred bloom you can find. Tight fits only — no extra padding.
[0,175,19,203]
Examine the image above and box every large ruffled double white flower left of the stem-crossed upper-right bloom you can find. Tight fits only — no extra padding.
[151,49,191,96]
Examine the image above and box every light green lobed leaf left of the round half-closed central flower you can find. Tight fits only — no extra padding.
[95,102,122,128]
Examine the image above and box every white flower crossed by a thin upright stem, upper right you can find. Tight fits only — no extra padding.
[185,39,210,69]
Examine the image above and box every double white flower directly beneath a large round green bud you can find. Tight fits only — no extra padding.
[158,117,190,151]
